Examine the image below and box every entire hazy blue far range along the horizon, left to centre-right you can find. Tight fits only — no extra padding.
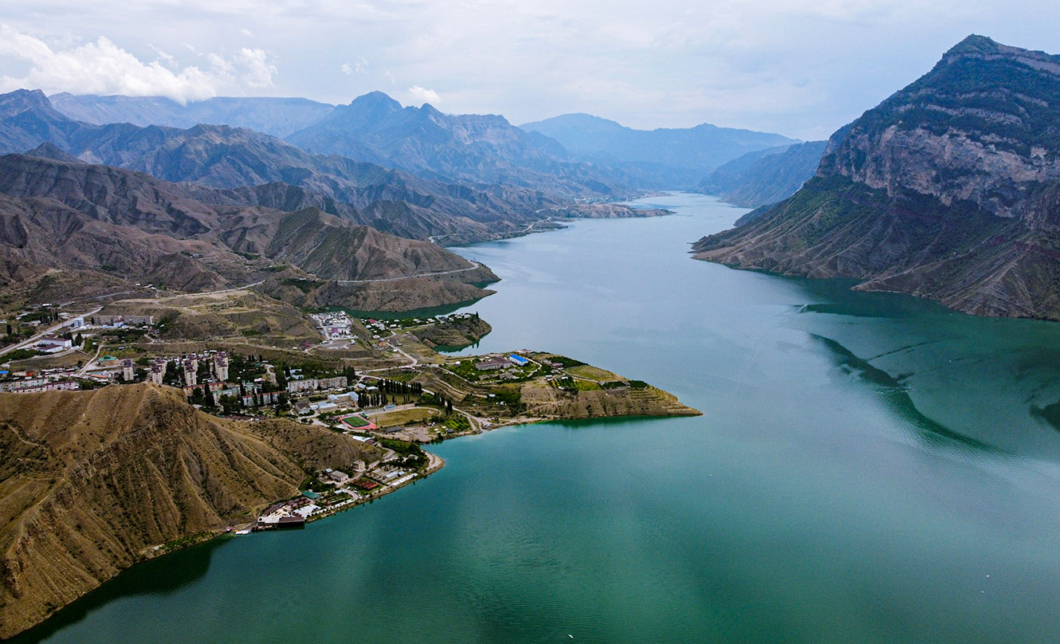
[43,92,795,193]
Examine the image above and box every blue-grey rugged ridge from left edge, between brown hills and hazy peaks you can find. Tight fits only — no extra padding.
[0,91,661,244]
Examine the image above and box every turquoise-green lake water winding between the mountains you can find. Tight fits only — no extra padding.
[20,195,1060,643]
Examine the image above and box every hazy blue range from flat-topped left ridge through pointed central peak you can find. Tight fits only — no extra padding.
[47,92,637,199]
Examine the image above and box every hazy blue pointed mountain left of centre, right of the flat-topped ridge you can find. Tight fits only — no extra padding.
[286,92,634,198]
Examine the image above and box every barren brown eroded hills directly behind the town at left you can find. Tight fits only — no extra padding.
[0,147,496,307]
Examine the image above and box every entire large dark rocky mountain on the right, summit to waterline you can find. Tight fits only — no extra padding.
[693,36,1060,319]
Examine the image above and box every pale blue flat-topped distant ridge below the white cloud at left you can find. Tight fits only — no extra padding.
[51,93,335,138]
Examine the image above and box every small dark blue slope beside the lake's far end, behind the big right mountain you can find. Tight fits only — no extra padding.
[699,141,828,208]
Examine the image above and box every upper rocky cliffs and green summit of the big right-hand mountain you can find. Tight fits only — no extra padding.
[820,36,1060,217]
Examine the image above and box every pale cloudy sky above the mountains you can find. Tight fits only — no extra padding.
[0,0,1060,140]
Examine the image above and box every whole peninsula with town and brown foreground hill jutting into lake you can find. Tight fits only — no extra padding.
[0,300,700,638]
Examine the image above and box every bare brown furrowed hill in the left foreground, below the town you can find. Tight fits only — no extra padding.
[0,384,378,638]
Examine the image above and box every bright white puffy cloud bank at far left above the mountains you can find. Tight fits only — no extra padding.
[0,24,277,103]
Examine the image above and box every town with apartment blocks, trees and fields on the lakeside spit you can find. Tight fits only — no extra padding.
[0,300,697,533]
